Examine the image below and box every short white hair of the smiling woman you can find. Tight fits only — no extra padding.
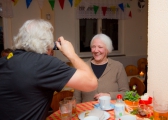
[90,33,113,53]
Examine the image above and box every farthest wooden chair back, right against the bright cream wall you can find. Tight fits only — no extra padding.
[137,58,148,73]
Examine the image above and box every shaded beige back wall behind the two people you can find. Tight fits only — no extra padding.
[2,0,148,66]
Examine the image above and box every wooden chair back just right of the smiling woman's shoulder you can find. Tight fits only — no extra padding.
[125,65,138,76]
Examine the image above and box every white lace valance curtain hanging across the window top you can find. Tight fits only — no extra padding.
[76,0,130,19]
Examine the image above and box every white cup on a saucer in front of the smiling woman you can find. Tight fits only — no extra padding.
[99,96,111,110]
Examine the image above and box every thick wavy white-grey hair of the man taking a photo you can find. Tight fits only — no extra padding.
[13,19,54,54]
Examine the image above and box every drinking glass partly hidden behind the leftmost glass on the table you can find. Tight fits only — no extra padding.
[64,97,76,116]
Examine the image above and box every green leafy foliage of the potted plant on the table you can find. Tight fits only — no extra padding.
[124,91,140,101]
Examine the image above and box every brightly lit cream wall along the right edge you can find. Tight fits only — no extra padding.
[148,0,168,100]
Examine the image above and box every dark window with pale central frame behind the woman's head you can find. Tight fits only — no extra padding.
[79,19,119,52]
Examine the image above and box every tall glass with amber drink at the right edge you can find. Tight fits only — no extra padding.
[153,90,168,120]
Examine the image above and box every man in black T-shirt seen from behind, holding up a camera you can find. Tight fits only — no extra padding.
[0,19,97,120]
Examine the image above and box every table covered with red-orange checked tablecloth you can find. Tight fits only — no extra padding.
[46,100,150,120]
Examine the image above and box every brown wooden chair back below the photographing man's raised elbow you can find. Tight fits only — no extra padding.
[51,90,73,112]
